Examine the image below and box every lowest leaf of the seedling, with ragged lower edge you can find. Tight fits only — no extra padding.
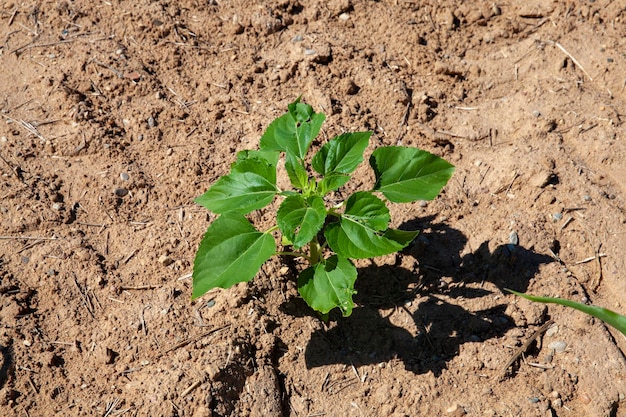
[298,255,357,317]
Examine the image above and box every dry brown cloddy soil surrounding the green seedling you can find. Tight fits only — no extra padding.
[0,0,626,417]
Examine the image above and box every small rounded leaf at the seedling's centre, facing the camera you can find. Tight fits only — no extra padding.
[276,194,326,249]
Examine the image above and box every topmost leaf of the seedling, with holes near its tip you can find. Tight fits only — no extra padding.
[260,98,326,159]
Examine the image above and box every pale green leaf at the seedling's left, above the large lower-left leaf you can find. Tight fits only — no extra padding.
[195,157,278,214]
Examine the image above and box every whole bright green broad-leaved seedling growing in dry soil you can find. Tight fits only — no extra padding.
[192,98,454,317]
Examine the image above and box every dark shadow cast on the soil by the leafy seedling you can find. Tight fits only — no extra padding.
[305,217,553,376]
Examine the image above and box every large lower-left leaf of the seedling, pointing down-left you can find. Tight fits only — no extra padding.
[192,212,276,299]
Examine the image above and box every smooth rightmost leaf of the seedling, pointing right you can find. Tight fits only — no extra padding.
[370,146,454,203]
